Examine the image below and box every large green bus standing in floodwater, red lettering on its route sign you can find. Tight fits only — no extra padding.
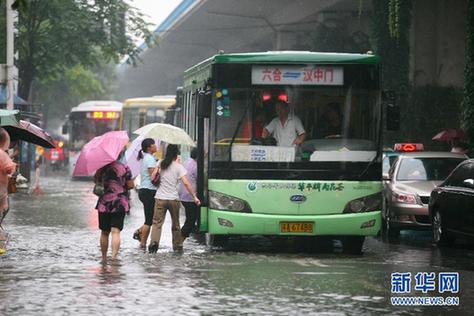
[179,51,382,253]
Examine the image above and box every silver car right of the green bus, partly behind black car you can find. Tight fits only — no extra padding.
[382,152,467,238]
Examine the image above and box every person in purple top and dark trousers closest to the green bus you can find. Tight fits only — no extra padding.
[179,148,199,241]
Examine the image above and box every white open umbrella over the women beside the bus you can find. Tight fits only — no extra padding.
[133,123,196,147]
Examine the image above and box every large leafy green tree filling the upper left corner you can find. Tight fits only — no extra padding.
[2,0,155,99]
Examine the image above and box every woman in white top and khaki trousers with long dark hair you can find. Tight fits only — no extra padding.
[148,144,201,252]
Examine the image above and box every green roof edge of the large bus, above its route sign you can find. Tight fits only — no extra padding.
[185,51,380,73]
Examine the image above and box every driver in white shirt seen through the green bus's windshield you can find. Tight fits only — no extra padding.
[262,100,306,147]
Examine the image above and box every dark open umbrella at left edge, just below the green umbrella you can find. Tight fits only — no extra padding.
[2,120,55,148]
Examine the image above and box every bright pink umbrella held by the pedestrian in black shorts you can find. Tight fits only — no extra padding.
[72,131,129,176]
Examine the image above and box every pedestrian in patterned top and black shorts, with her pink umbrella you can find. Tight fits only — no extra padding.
[73,131,133,263]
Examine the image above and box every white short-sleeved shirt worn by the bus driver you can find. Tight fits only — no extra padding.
[265,115,305,147]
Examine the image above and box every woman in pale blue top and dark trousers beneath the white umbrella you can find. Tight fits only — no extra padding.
[133,138,157,248]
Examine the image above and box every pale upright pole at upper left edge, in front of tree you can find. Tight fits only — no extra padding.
[5,0,15,110]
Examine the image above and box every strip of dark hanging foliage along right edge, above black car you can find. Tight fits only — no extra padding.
[461,0,474,154]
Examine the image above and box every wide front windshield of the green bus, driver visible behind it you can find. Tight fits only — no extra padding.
[211,86,380,165]
